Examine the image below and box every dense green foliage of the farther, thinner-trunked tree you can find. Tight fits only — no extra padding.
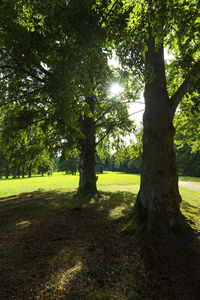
[0,0,135,169]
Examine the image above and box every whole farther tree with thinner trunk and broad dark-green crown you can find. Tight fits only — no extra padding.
[0,0,136,193]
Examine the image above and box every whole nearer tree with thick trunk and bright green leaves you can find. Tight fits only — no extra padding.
[99,0,200,233]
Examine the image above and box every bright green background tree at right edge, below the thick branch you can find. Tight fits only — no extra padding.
[174,89,200,177]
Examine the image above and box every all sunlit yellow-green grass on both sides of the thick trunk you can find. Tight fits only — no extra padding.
[0,172,200,230]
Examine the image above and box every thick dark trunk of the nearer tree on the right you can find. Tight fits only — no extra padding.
[136,37,183,233]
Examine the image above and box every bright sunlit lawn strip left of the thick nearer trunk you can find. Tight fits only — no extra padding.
[0,172,140,197]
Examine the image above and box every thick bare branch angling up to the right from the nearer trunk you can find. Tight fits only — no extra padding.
[171,60,200,110]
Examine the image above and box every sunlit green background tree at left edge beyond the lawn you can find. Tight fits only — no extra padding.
[0,103,52,178]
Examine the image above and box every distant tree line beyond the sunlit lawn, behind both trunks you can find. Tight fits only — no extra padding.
[0,139,200,178]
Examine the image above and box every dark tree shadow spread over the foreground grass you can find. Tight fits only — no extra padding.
[0,191,200,300]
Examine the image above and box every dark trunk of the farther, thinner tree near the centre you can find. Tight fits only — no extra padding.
[78,97,97,195]
